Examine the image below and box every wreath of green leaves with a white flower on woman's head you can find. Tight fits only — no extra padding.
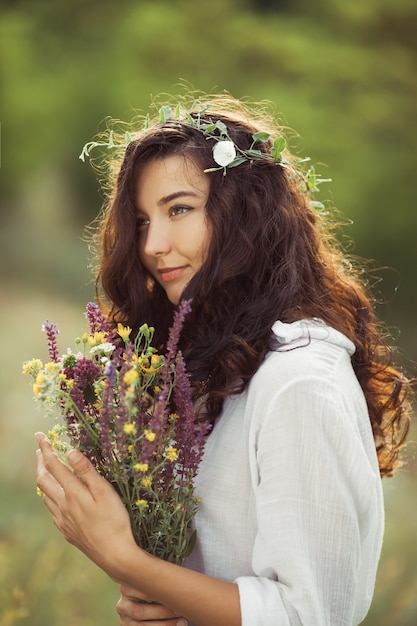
[79,104,331,209]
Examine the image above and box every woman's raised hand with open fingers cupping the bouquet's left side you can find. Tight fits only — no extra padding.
[36,433,136,582]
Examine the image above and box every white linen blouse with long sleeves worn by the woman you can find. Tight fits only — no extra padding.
[186,320,384,626]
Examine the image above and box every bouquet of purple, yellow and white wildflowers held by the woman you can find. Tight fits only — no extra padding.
[23,301,208,564]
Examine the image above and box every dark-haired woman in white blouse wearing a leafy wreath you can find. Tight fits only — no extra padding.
[37,96,409,626]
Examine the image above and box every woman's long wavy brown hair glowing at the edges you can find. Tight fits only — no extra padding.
[88,91,410,476]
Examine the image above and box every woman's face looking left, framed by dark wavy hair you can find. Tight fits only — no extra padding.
[135,156,210,304]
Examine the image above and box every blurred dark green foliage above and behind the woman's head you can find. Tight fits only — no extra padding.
[0,0,417,357]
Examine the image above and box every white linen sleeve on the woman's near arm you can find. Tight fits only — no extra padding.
[236,377,383,626]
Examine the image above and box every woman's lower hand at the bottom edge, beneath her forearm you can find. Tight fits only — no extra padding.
[116,585,187,626]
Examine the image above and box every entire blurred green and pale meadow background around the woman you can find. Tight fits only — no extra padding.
[0,0,417,626]
